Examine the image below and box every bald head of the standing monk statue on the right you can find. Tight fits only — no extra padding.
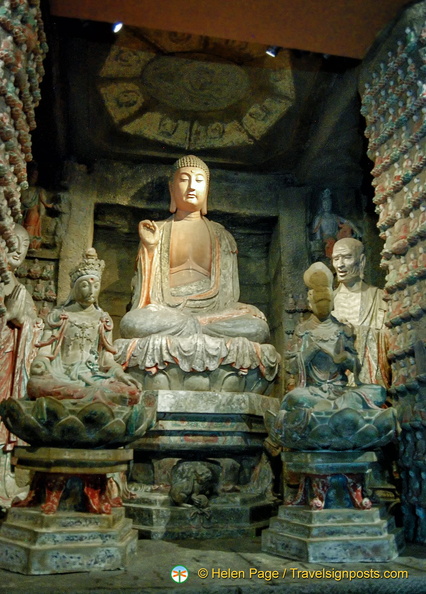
[331,237,365,286]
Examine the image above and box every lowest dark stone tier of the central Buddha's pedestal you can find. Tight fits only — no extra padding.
[124,492,278,540]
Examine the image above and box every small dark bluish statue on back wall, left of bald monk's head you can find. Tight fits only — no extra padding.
[310,188,361,263]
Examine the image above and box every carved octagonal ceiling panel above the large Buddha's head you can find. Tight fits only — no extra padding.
[97,30,295,160]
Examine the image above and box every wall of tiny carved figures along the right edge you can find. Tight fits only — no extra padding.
[360,2,426,543]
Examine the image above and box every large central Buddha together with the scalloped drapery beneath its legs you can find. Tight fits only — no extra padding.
[116,155,278,391]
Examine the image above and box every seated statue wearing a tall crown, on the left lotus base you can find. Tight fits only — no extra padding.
[27,248,140,406]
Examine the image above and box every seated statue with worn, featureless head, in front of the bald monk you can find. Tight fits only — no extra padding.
[281,262,386,411]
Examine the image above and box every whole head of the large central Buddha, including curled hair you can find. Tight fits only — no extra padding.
[169,155,210,215]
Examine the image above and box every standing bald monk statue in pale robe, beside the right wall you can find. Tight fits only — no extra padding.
[332,238,390,388]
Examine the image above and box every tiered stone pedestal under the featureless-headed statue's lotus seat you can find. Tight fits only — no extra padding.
[262,451,404,563]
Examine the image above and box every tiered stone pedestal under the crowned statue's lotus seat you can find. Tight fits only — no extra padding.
[0,447,138,575]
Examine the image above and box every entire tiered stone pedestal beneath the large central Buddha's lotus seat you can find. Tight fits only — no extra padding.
[125,390,279,539]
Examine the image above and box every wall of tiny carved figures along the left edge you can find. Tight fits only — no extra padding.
[0,0,47,306]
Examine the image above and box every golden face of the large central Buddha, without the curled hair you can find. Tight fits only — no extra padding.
[170,167,208,214]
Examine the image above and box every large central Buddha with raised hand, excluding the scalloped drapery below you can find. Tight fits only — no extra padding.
[120,155,269,343]
